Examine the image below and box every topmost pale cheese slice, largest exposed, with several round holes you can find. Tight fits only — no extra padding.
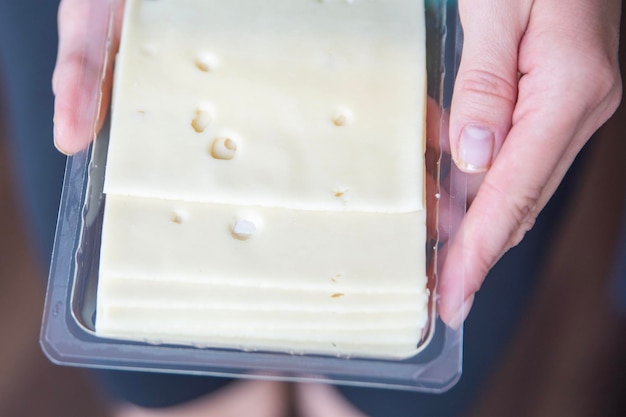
[105,0,425,213]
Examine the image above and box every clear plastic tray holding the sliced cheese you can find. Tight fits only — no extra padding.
[40,0,466,392]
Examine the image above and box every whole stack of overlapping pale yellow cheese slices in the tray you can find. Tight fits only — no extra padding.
[96,0,428,357]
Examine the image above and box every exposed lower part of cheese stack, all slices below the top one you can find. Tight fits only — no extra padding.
[97,196,428,357]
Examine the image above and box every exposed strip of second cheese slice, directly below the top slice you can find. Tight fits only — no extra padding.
[100,195,426,292]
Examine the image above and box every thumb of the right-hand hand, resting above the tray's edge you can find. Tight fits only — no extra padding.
[450,0,529,172]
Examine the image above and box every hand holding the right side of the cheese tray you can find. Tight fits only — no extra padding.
[439,0,621,327]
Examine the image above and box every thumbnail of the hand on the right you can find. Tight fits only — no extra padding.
[459,125,495,172]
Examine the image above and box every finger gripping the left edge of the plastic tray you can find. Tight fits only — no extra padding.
[52,0,122,154]
